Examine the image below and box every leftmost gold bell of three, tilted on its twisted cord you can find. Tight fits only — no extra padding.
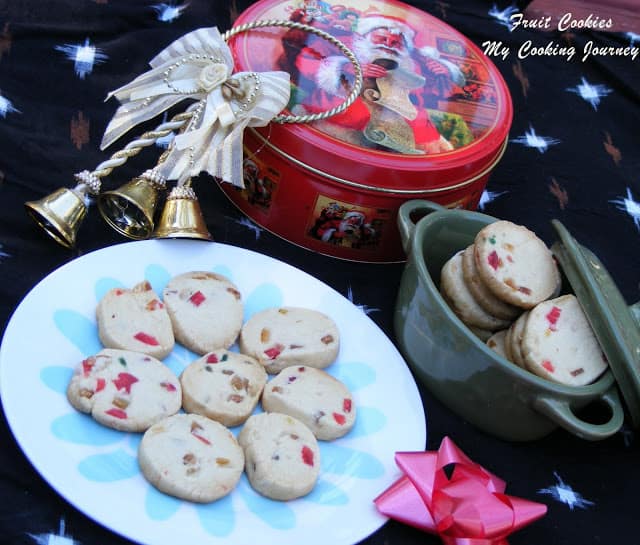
[24,184,87,248]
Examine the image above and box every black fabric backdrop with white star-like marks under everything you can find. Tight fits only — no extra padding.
[0,0,640,545]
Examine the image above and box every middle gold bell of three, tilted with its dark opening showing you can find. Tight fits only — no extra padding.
[98,170,165,240]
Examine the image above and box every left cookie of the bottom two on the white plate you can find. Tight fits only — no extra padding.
[138,414,244,503]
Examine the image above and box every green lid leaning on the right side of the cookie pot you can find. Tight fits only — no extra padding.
[551,220,640,428]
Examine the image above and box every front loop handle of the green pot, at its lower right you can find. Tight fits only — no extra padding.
[533,385,624,441]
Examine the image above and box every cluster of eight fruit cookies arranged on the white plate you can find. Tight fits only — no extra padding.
[67,271,356,503]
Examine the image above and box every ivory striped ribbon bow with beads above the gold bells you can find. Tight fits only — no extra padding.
[100,28,290,187]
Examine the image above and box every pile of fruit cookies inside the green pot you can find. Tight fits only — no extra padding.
[440,221,607,386]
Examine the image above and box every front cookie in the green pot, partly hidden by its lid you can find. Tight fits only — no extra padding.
[521,295,607,386]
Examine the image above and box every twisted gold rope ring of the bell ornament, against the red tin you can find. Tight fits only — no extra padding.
[222,19,363,123]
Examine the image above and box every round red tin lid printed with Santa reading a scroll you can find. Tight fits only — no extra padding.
[229,0,513,185]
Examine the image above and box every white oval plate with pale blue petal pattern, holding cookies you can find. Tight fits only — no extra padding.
[0,240,426,545]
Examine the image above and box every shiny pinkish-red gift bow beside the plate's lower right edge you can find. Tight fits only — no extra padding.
[374,437,547,545]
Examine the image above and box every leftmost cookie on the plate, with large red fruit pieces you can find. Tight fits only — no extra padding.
[67,348,182,432]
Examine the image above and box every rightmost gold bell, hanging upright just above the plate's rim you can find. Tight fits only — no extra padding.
[154,185,213,240]
